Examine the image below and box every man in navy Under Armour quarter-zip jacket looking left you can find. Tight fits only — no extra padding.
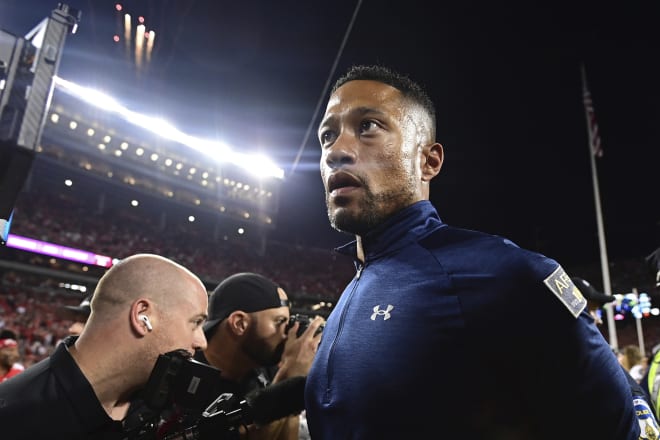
[305,66,644,440]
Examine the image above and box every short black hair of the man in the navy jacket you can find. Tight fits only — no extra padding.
[331,64,435,124]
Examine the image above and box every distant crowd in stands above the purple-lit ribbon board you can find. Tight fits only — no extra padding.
[12,192,353,300]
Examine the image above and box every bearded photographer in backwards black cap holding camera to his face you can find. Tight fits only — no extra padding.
[196,272,323,440]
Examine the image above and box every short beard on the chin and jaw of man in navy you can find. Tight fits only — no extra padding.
[325,178,415,236]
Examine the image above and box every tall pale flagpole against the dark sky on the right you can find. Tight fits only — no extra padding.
[581,64,619,350]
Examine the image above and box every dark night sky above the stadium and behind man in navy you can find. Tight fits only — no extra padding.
[0,0,660,262]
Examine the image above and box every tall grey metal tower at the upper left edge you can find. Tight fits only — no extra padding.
[0,3,81,244]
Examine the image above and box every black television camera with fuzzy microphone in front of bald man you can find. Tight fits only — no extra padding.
[125,350,305,440]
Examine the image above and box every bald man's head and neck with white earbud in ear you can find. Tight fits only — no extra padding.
[73,254,208,391]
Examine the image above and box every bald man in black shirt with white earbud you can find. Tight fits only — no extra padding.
[0,254,208,439]
